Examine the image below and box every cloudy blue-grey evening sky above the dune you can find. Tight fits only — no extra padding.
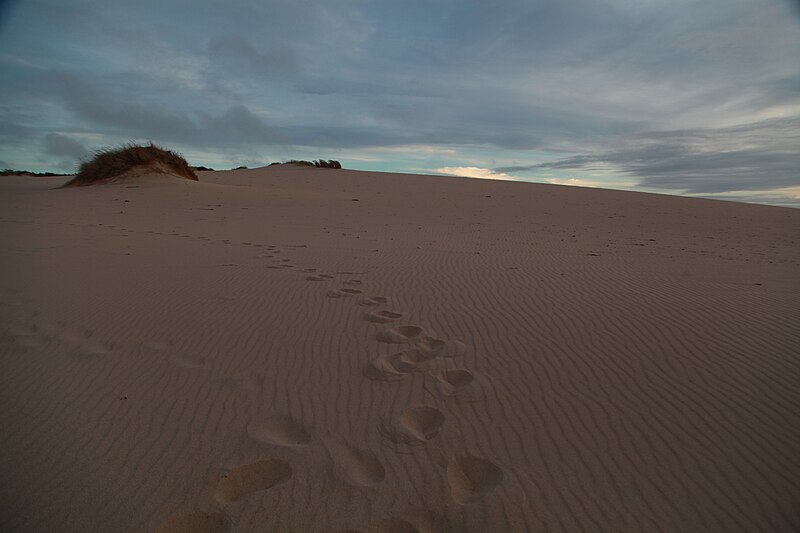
[0,0,800,207]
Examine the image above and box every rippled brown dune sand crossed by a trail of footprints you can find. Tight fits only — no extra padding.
[0,167,800,532]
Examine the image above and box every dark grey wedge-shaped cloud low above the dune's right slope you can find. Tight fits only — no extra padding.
[494,118,800,194]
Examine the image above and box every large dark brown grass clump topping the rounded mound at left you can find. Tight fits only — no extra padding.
[63,143,198,187]
